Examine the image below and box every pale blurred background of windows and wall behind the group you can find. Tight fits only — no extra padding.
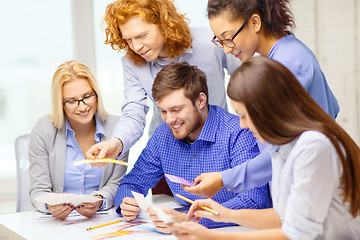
[0,0,360,214]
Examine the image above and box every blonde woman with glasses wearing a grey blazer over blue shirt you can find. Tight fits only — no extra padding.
[29,60,127,220]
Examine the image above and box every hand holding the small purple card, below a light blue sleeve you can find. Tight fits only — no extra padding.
[181,172,224,198]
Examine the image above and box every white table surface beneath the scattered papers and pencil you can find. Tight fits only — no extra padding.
[0,195,249,240]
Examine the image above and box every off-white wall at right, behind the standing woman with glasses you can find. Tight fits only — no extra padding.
[292,0,360,144]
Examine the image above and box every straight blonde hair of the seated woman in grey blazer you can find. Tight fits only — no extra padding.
[49,60,108,129]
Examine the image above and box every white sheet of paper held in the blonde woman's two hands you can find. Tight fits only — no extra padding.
[35,193,101,207]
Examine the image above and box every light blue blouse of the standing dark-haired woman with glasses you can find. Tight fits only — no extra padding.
[221,34,339,192]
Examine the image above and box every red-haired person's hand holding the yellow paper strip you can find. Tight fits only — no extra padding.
[85,137,123,167]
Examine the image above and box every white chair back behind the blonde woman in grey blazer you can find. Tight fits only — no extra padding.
[15,134,34,212]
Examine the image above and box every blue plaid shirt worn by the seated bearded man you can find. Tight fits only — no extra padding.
[114,105,268,228]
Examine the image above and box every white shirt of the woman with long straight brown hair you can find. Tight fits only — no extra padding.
[269,131,360,240]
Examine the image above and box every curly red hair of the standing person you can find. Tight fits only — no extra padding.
[102,0,192,64]
